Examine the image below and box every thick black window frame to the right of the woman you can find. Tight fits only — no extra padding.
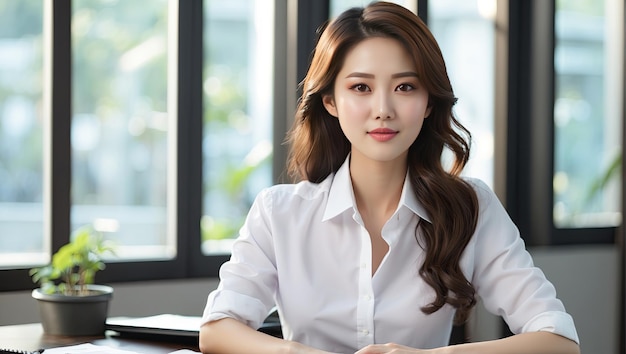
[505,0,620,246]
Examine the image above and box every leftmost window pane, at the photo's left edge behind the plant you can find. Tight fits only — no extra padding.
[0,0,45,268]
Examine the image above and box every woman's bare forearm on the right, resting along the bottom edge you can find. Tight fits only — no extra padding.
[356,332,580,354]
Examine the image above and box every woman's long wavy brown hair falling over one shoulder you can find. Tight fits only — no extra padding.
[287,2,478,323]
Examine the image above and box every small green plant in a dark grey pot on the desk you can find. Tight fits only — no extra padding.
[29,225,113,336]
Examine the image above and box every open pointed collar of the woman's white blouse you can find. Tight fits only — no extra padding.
[322,154,431,222]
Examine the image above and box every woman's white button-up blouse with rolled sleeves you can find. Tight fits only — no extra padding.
[202,160,578,353]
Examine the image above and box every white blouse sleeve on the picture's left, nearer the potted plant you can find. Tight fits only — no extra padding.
[202,190,277,329]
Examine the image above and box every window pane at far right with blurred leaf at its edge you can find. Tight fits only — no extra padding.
[553,0,624,228]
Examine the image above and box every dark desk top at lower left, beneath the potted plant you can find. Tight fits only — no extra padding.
[0,323,199,354]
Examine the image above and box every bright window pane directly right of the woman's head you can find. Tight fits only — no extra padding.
[428,0,496,188]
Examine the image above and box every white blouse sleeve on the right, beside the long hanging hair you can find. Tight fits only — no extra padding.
[464,180,579,343]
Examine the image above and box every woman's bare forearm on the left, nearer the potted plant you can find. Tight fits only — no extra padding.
[200,318,336,354]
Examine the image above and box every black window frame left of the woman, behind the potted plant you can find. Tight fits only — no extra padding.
[0,0,304,292]
